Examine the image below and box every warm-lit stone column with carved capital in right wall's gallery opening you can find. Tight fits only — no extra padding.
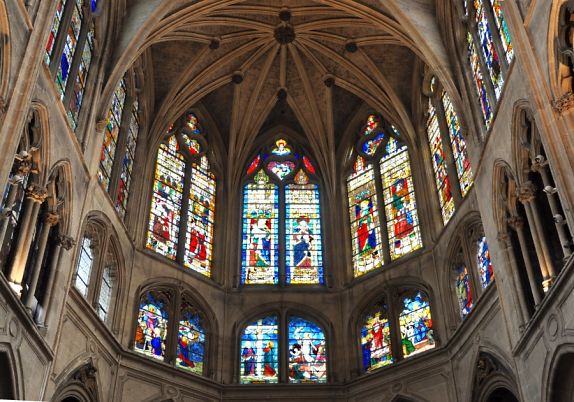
[517,181,556,292]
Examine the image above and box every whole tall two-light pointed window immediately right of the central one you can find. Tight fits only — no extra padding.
[347,115,422,277]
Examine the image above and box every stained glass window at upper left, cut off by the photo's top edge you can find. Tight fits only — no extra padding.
[44,0,98,130]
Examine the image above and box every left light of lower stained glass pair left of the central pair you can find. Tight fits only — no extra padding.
[134,292,168,360]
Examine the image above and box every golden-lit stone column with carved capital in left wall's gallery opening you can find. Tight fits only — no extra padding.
[8,184,48,295]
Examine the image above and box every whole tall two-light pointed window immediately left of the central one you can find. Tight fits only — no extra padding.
[146,112,216,277]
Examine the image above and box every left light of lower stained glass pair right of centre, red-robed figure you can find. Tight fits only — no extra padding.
[361,303,394,371]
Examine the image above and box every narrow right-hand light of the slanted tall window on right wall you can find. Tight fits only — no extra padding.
[441,91,473,197]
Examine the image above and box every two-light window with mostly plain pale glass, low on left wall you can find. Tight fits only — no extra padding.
[73,216,121,330]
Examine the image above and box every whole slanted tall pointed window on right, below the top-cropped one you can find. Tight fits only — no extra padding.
[426,77,472,225]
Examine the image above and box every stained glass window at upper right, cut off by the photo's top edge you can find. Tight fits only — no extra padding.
[461,0,514,129]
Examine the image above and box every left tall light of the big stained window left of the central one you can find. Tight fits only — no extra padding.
[147,136,185,260]
